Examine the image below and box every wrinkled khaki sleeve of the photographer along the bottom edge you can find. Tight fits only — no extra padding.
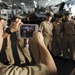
[0,64,50,75]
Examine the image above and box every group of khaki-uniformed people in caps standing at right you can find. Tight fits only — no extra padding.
[39,11,75,60]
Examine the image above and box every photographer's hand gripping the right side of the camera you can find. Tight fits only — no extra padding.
[33,32,44,44]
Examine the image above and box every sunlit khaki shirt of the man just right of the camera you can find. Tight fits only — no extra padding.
[39,21,53,46]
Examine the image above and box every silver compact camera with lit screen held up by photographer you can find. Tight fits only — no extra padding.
[18,24,38,38]
